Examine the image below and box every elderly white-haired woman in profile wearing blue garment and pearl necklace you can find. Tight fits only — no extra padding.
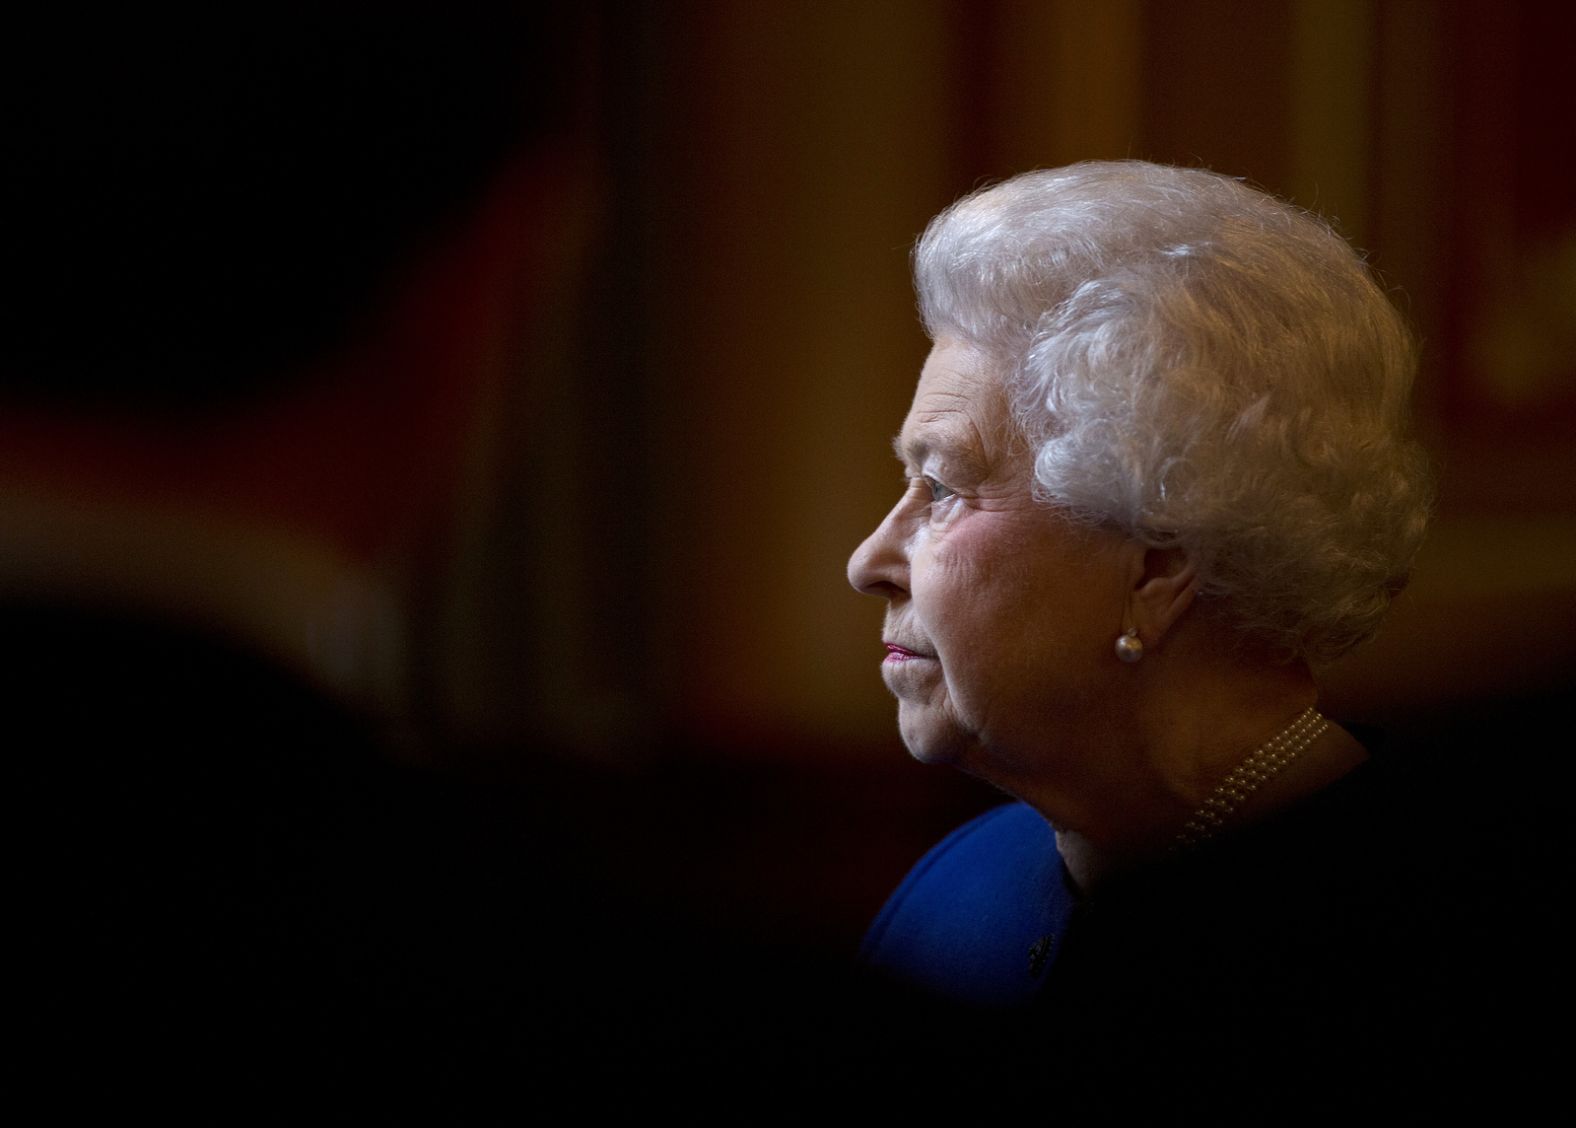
[848,161,1538,1109]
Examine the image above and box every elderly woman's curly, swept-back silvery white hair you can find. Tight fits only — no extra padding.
[914,161,1433,665]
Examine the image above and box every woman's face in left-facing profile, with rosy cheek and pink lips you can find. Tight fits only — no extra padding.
[848,340,1132,789]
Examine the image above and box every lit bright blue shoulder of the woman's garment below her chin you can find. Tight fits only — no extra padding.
[860,803,1073,1007]
